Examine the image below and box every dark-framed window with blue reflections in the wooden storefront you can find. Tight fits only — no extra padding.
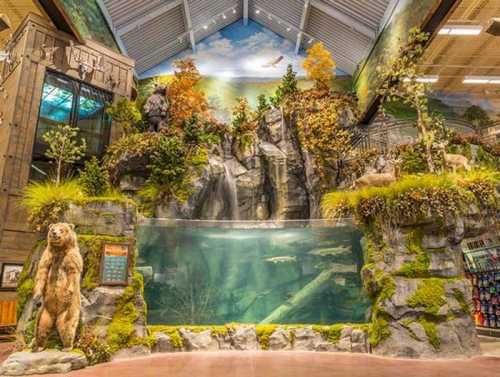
[31,72,113,180]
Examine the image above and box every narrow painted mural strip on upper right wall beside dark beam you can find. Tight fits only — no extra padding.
[355,0,440,116]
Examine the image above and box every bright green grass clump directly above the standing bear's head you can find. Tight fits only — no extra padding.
[22,181,84,231]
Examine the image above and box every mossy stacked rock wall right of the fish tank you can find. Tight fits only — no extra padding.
[362,207,494,358]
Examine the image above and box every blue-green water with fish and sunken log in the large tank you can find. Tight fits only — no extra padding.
[138,223,369,324]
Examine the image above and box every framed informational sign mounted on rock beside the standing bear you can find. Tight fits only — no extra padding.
[101,243,130,285]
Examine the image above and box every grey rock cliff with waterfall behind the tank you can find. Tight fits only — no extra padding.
[120,109,350,220]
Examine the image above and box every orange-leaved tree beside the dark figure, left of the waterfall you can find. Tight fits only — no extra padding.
[168,58,210,126]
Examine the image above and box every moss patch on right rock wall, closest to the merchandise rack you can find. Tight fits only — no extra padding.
[408,278,446,316]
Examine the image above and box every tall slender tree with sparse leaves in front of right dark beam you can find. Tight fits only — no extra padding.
[377,28,436,173]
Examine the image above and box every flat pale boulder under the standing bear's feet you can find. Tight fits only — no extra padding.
[0,350,88,376]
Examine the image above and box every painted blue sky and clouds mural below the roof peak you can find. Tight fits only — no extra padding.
[141,20,351,121]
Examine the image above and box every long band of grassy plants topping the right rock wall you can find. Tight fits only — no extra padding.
[322,170,500,225]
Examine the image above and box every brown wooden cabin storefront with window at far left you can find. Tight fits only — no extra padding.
[0,0,134,326]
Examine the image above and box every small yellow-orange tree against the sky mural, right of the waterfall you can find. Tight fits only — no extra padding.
[302,42,336,90]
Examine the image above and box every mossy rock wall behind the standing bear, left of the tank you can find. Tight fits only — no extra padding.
[17,200,146,353]
